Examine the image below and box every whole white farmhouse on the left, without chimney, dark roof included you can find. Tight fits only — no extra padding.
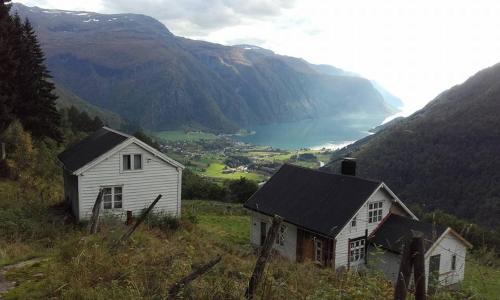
[58,127,184,221]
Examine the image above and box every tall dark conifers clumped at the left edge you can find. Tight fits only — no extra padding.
[0,0,62,142]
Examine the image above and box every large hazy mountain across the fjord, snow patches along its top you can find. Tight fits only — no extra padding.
[13,4,392,131]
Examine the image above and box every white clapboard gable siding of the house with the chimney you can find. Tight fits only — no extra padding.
[335,189,393,268]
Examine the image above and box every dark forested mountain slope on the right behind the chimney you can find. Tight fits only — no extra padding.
[327,64,500,226]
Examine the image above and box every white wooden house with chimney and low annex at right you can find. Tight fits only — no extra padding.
[244,161,471,285]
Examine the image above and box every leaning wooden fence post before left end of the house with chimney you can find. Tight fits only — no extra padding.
[245,215,283,299]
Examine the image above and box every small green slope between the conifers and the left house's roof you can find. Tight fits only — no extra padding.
[55,84,125,129]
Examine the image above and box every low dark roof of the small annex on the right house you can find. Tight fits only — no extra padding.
[370,214,446,253]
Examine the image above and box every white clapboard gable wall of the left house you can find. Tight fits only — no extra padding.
[78,144,182,219]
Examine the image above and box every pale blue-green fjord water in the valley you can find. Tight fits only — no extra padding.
[236,115,385,150]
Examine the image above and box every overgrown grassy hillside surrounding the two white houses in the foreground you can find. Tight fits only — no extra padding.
[0,121,499,299]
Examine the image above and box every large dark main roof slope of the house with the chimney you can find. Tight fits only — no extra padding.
[244,164,381,237]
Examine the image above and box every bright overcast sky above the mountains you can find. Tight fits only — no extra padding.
[14,0,500,112]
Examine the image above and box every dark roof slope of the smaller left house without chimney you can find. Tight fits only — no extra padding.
[57,127,129,172]
